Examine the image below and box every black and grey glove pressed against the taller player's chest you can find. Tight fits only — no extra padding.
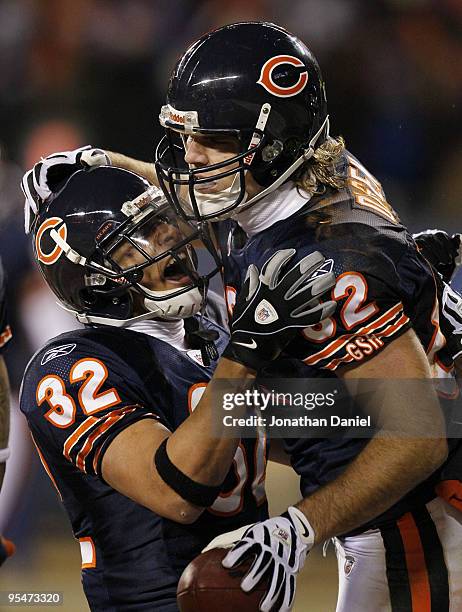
[223,249,336,370]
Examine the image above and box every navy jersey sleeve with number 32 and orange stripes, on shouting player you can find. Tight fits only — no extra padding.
[20,341,164,476]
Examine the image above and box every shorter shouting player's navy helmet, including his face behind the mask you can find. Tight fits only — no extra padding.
[32,166,216,326]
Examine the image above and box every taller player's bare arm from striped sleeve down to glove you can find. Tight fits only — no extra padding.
[300,331,447,541]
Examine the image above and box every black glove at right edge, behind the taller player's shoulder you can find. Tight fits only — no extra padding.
[413,230,462,283]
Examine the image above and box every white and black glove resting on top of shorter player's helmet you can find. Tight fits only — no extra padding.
[21,145,111,234]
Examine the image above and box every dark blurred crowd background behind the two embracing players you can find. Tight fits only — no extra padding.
[0,0,462,612]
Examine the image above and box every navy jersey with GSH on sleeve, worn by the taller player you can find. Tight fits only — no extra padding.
[217,153,458,520]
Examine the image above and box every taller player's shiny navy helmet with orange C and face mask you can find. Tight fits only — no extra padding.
[156,22,329,221]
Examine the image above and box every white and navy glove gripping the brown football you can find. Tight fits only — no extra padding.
[222,506,314,612]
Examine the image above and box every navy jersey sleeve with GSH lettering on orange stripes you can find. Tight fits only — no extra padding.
[289,235,418,371]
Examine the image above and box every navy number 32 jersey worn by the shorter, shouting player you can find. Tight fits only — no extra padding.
[20,321,267,612]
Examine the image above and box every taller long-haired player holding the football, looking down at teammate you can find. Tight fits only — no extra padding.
[24,23,462,612]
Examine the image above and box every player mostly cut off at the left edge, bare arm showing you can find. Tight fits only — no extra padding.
[0,260,15,565]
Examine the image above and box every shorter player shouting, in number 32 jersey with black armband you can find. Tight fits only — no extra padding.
[20,164,334,612]
